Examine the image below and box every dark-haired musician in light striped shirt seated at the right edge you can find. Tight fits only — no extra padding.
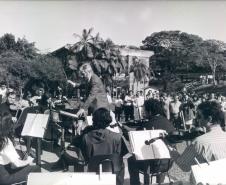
[174,101,226,172]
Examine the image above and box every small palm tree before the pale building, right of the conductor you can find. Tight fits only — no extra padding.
[130,57,149,92]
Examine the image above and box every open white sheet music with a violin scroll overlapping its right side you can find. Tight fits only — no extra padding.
[129,130,170,160]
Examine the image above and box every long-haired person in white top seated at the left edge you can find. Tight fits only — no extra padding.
[0,110,40,185]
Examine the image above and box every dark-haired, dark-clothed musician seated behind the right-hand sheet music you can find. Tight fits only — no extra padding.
[128,99,175,185]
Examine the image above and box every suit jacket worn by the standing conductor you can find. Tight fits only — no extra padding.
[82,74,109,113]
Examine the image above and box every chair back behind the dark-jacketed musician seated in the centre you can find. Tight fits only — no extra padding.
[88,154,123,173]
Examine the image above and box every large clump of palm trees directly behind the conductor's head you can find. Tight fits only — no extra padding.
[69,28,124,89]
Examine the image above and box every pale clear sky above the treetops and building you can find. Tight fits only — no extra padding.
[0,0,226,53]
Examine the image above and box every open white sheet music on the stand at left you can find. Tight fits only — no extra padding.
[21,113,49,138]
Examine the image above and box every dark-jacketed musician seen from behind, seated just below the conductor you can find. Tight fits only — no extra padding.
[52,108,124,185]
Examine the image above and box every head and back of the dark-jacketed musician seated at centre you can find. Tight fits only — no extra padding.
[81,108,124,185]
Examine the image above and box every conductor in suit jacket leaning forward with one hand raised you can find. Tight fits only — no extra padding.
[68,63,109,116]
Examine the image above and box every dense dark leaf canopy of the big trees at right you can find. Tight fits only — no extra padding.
[141,31,226,86]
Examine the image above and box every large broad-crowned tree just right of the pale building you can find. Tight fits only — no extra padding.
[141,31,203,88]
